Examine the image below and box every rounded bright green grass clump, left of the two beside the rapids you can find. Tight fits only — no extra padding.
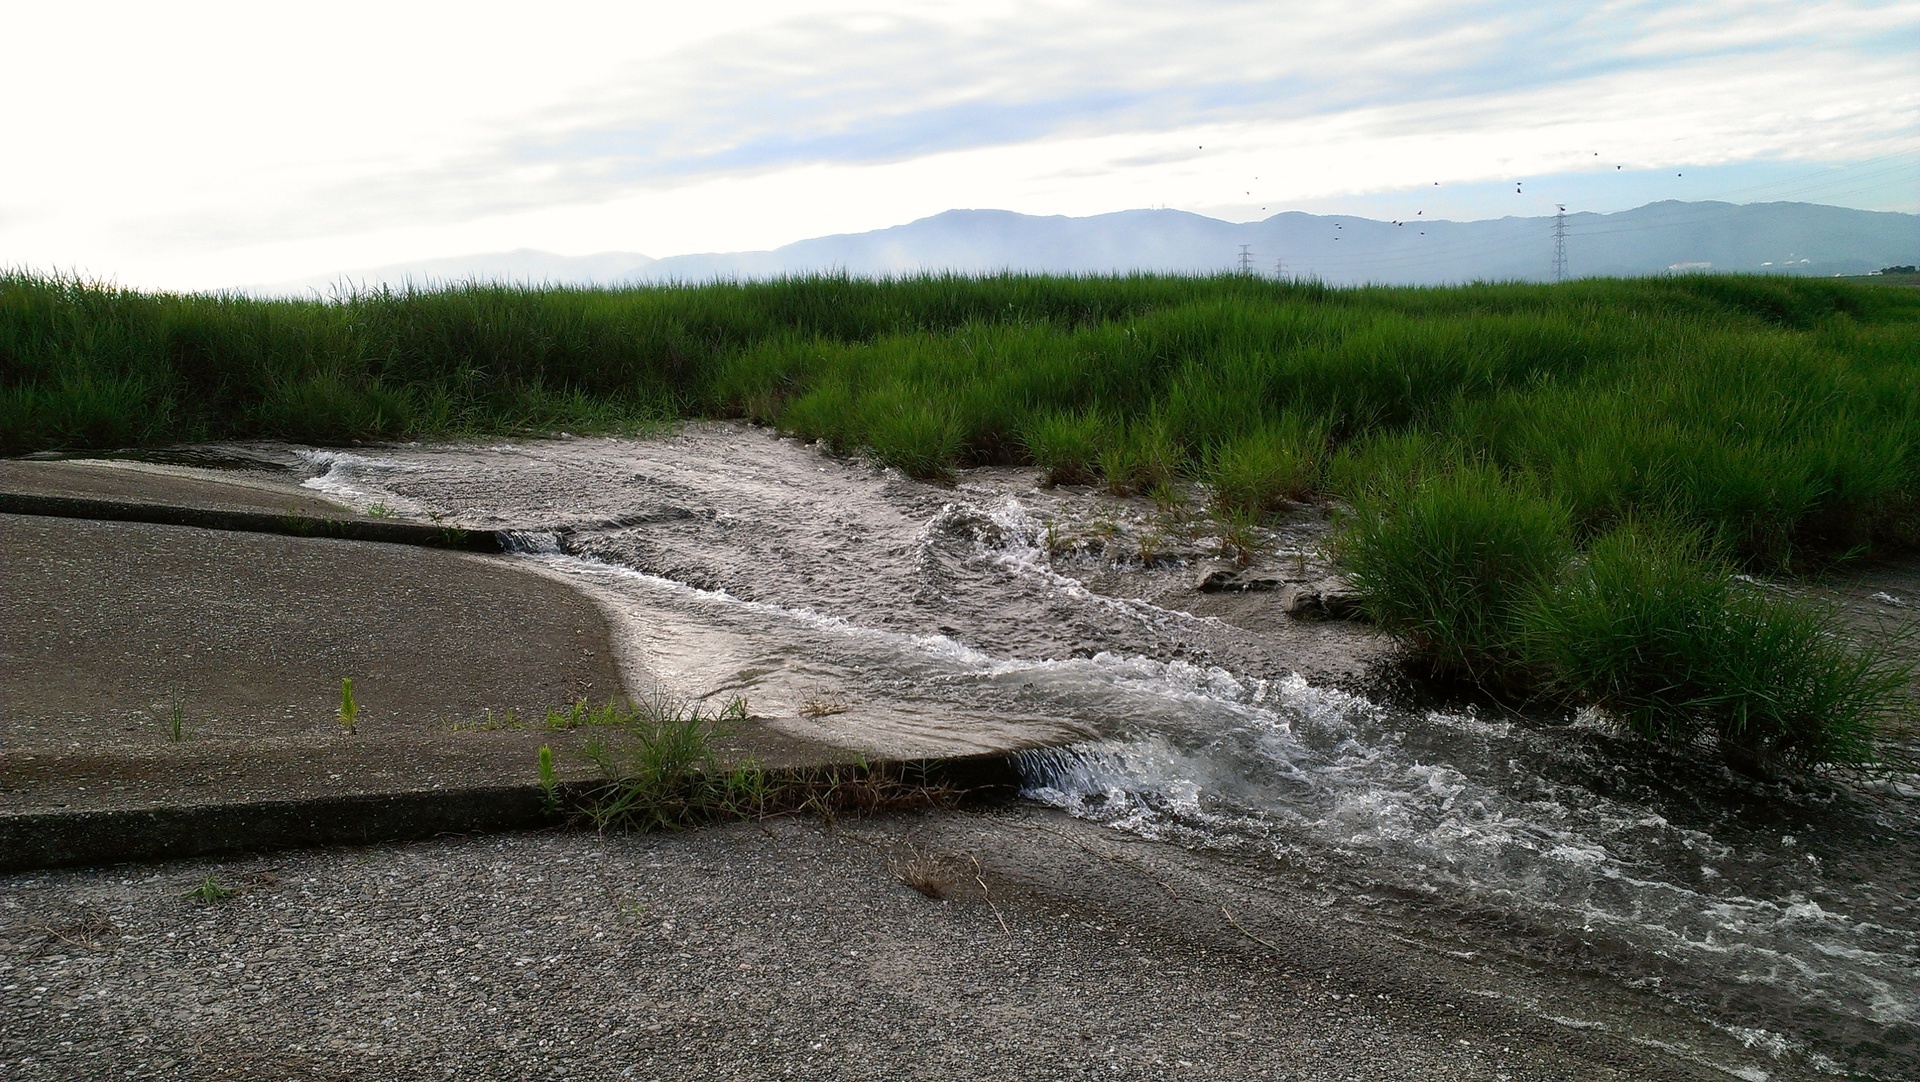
[1334,466,1569,687]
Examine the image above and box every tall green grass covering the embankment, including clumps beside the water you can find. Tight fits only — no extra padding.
[0,276,1920,767]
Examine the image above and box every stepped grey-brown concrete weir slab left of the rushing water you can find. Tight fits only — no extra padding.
[0,462,1008,869]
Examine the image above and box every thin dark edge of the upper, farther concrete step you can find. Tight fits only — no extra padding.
[0,493,505,553]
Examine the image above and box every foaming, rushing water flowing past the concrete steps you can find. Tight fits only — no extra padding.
[217,426,1920,1078]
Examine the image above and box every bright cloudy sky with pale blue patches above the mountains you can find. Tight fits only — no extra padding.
[0,0,1920,290]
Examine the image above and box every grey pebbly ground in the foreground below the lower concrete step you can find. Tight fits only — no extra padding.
[0,804,1793,1080]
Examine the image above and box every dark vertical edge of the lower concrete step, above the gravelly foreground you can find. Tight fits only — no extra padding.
[0,752,1020,873]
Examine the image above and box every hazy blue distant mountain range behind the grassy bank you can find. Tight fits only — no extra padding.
[270,201,1920,294]
